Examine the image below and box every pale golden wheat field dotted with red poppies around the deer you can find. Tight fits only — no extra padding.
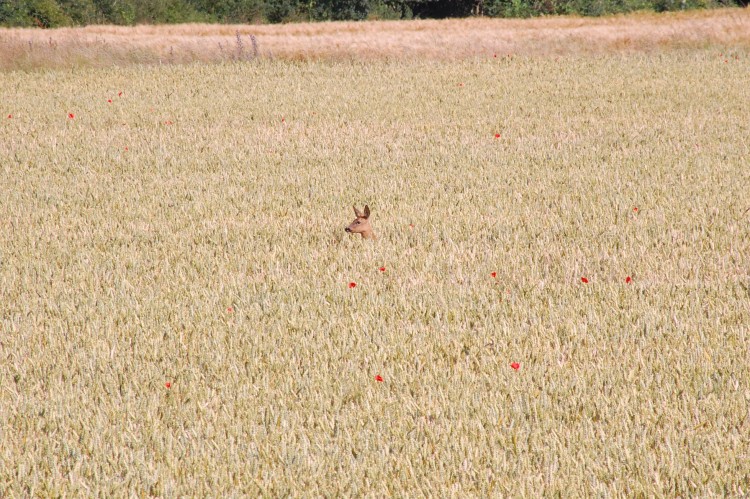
[0,38,750,497]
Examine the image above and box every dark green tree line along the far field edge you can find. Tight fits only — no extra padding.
[0,0,748,28]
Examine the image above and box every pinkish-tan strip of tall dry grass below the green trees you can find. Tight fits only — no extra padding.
[0,8,750,70]
